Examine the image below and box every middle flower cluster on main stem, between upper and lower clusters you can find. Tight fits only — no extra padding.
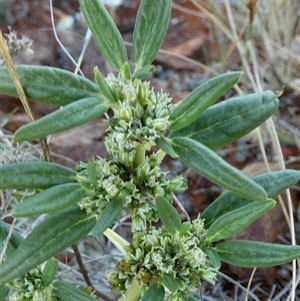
[78,154,186,231]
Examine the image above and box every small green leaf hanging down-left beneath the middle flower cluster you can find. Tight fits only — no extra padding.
[91,198,123,235]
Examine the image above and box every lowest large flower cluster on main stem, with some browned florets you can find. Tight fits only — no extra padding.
[108,216,217,301]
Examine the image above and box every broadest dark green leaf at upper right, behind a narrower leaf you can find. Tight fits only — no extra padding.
[169,91,279,149]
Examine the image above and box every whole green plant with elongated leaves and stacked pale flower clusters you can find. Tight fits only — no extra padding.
[0,0,300,301]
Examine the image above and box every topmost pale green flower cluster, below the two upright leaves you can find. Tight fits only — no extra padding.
[105,74,172,166]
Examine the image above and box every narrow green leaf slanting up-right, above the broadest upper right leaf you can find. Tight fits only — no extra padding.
[170,72,242,130]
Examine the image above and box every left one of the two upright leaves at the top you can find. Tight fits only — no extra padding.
[79,0,127,70]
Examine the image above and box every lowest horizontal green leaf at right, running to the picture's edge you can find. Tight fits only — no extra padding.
[215,240,300,267]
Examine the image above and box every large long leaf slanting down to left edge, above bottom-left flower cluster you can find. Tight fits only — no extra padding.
[0,207,96,286]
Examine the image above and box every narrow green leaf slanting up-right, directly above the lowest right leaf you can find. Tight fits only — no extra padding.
[207,199,276,242]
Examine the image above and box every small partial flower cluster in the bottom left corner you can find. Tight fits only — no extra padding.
[7,262,52,301]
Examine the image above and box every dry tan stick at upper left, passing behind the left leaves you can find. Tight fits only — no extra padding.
[0,30,51,162]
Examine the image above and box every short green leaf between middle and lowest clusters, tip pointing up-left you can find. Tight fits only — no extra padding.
[156,196,181,234]
